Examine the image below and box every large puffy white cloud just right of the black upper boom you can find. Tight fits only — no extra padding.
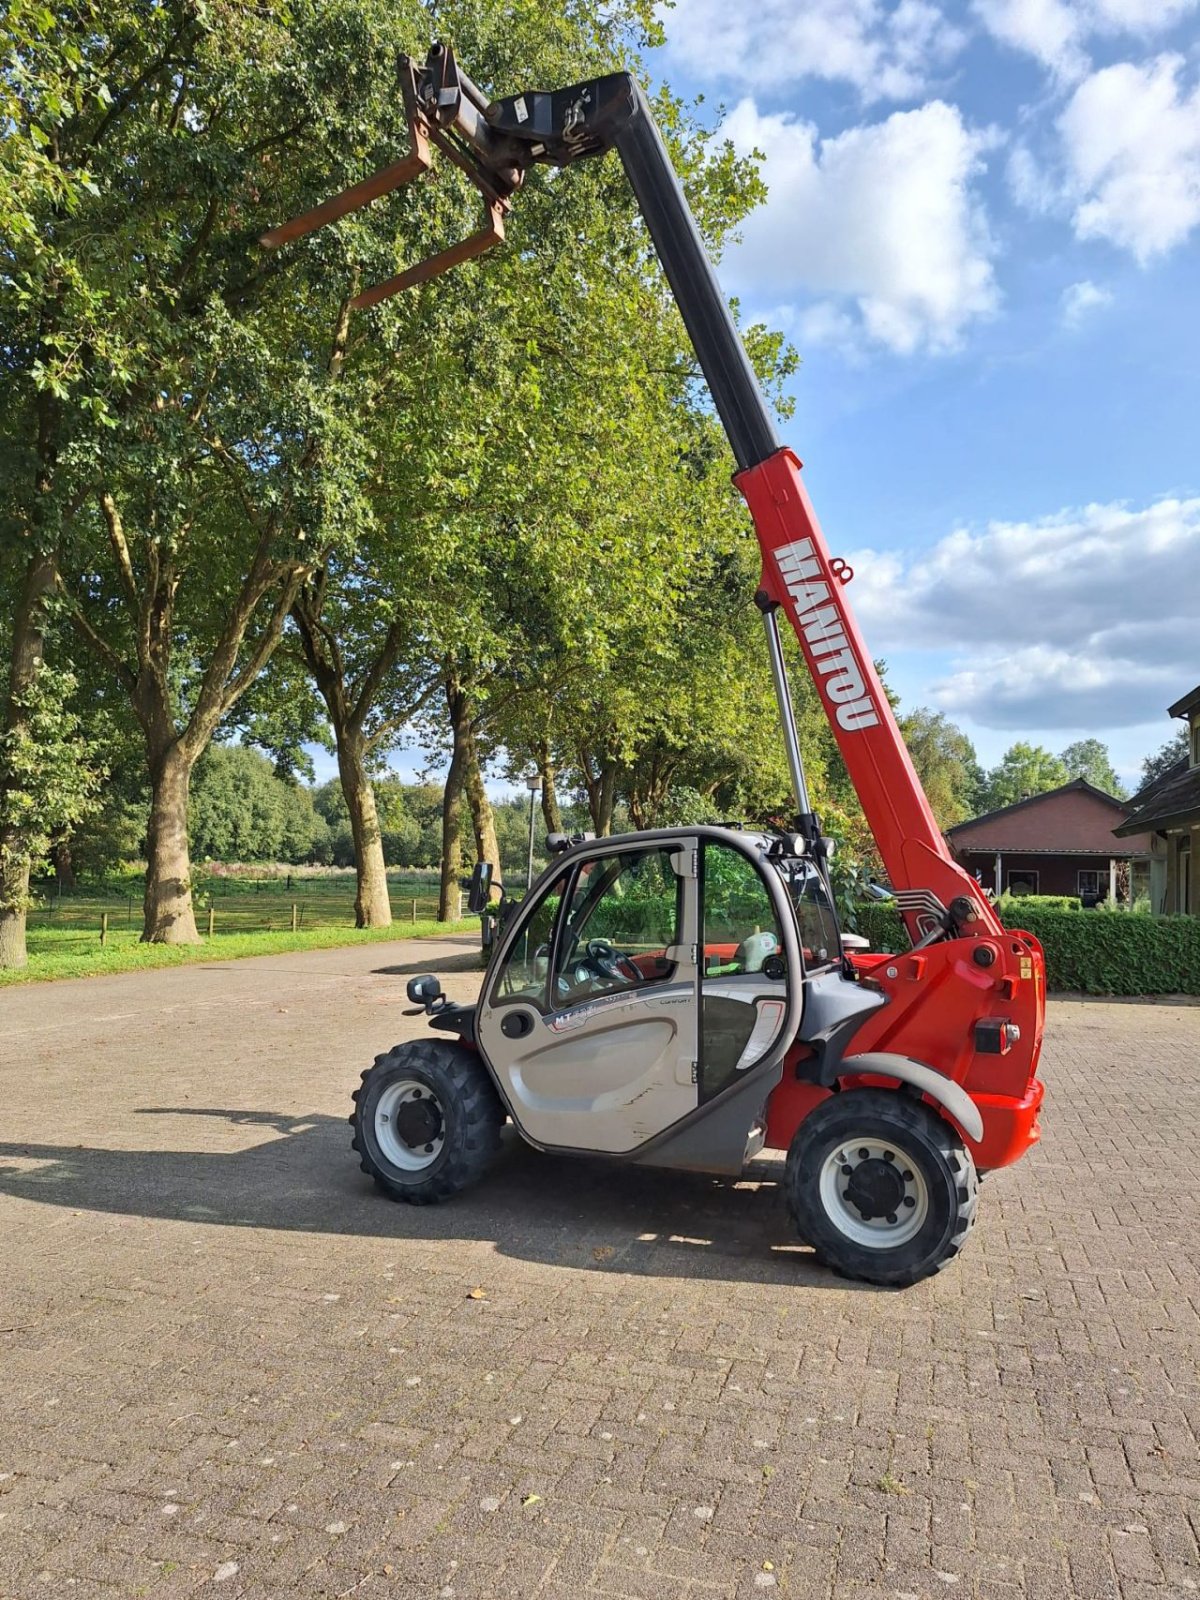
[720,99,998,355]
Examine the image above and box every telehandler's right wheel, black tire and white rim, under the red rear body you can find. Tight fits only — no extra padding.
[784,1090,978,1286]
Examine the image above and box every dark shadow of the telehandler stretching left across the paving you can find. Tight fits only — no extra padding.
[0,1106,866,1291]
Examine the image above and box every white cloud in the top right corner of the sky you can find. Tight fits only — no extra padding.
[973,0,1200,80]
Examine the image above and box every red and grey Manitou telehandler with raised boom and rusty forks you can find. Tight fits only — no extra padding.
[264,45,1045,1283]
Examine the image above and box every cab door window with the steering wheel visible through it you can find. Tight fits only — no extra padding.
[552,850,682,1010]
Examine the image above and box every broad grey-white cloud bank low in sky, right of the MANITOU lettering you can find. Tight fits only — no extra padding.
[848,499,1200,730]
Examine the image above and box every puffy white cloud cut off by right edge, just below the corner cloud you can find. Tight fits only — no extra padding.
[1058,54,1200,262]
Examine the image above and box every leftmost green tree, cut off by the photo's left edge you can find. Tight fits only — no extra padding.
[0,0,113,966]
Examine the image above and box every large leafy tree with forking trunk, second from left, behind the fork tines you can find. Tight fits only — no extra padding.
[0,0,502,941]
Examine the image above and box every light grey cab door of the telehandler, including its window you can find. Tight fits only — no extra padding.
[477,837,699,1154]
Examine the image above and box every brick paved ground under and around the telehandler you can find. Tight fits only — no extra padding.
[0,944,1200,1600]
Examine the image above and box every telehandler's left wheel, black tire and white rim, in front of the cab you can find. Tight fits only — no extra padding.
[350,1038,504,1205]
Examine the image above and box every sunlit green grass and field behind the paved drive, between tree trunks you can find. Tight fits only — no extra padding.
[0,872,478,984]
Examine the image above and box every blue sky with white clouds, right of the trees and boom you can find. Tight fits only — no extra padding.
[656,0,1200,779]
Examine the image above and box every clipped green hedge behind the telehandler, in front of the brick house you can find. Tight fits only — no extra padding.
[854,901,1200,995]
